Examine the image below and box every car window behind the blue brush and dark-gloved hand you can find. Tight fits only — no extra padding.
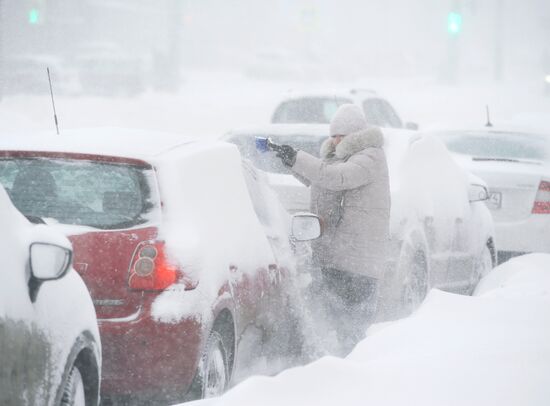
[227,134,325,174]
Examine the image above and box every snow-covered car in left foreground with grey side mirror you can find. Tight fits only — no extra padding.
[0,186,101,406]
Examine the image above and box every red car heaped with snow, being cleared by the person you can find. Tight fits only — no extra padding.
[0,129,320,402]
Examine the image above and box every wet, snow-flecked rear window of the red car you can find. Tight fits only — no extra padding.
[0,158,158,229]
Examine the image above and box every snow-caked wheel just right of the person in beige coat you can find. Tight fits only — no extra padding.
[401,251,428,312]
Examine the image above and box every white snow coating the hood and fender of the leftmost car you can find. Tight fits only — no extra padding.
[0,186,101,405]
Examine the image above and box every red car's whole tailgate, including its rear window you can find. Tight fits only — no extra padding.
[0,151,164,319]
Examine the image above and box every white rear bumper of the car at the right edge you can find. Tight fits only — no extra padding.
[495,214,550,253]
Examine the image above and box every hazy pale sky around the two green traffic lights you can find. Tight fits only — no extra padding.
[0,0,550,80]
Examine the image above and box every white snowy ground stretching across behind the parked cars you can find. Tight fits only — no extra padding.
[0,72,550,137]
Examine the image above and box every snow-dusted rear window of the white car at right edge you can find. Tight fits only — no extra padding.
[438,132,550,161]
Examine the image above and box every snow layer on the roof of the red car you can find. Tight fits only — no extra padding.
[0,128,202,158]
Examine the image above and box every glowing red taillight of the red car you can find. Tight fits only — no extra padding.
[128,241,197,290]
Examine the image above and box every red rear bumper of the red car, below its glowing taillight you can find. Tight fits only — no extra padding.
[99,304,201,399]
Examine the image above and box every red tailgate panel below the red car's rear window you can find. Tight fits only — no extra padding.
[69,227,157,319]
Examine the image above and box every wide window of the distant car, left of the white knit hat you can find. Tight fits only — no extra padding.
[272,97,352,124]
